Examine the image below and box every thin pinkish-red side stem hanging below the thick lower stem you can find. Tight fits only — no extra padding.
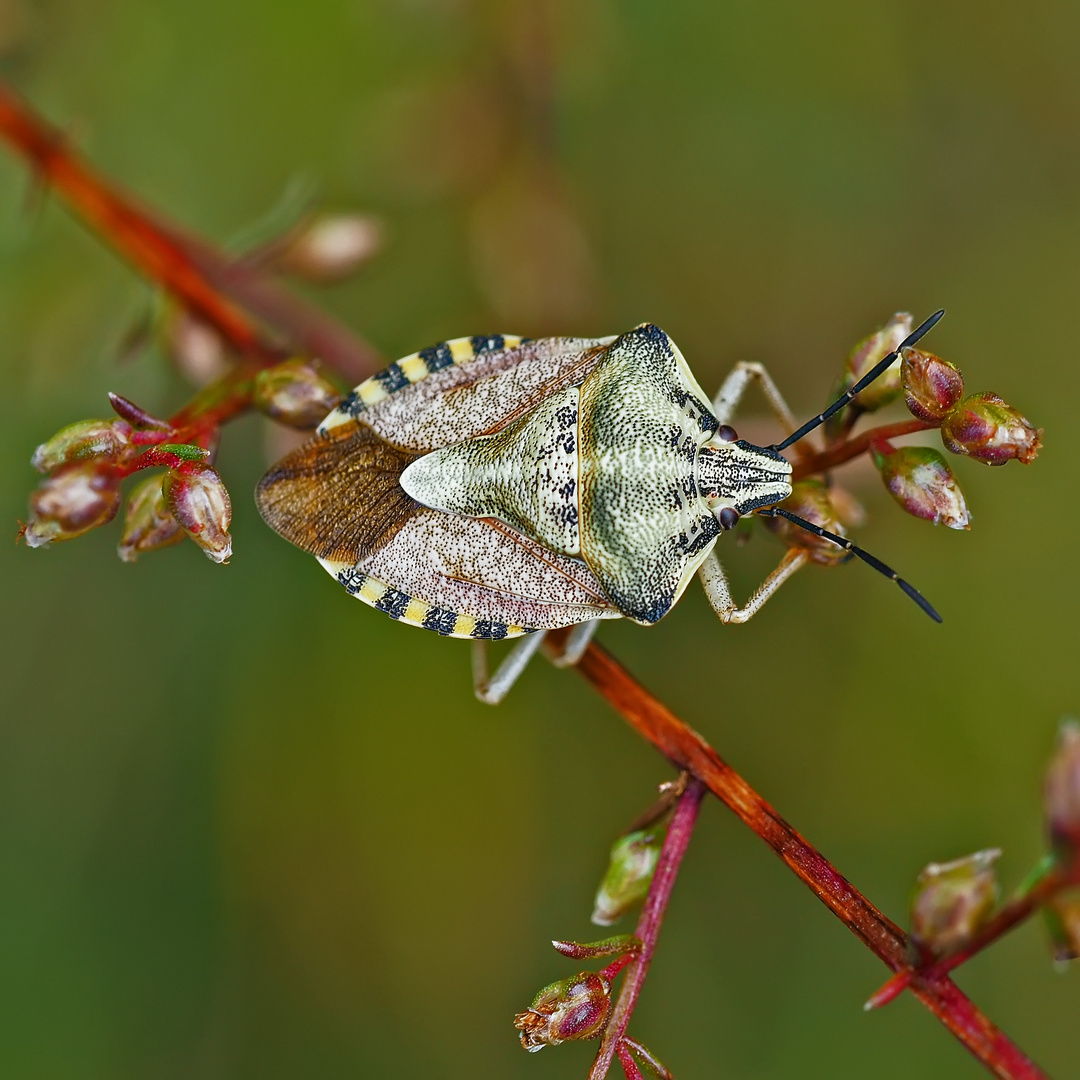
[589,779,705,1080]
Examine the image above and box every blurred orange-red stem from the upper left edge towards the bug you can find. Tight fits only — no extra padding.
[0,81,381,379]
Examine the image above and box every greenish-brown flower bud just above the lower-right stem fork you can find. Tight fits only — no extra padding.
[912,848,1001,956]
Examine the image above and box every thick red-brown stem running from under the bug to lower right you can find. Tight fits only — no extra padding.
[550,634,1045,1080]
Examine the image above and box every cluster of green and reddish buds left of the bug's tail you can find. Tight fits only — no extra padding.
[23,394,232,563]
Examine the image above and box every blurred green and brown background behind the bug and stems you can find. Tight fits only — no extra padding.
[0,0,1080,1080]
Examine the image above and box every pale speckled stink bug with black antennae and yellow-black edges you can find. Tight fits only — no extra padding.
[256,312,943,702]
